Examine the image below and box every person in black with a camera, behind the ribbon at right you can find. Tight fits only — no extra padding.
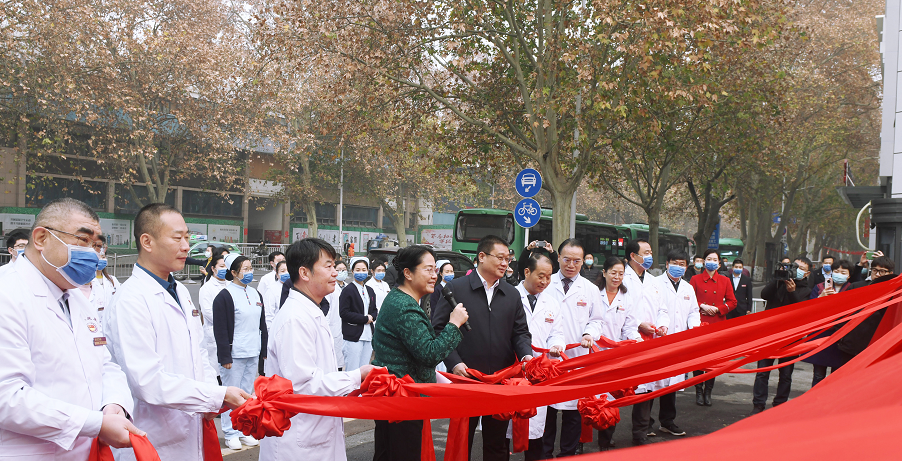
[752,256,811,415]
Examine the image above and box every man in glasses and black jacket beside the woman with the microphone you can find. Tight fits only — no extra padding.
[432,235,532,461]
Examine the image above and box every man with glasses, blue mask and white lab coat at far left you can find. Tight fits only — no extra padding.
[0,198,144,461]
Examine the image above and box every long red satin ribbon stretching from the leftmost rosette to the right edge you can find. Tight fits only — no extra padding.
[232,278,902,459]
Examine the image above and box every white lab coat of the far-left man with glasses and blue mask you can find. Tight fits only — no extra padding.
[0,257,134,461]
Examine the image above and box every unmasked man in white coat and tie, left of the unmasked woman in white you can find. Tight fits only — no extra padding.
[530,239,604,459]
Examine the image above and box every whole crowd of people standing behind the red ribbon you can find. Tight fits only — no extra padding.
[0,199,895,461]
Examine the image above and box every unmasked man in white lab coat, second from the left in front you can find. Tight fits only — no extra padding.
[103,203,250,461]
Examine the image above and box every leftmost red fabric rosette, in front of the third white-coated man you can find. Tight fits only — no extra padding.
[231,375,297,440]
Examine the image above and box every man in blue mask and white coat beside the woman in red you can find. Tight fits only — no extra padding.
[648,250,701,435]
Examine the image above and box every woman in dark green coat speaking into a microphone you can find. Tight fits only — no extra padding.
[373,245,467,461]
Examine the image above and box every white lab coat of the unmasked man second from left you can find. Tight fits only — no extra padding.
[104,265,226,461]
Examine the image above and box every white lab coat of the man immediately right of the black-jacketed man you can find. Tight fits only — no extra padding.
[507,282,564,440]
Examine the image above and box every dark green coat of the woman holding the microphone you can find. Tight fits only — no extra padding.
[373,288,463,383]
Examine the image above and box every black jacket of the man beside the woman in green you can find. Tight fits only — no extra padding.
[432,270,533,373]
